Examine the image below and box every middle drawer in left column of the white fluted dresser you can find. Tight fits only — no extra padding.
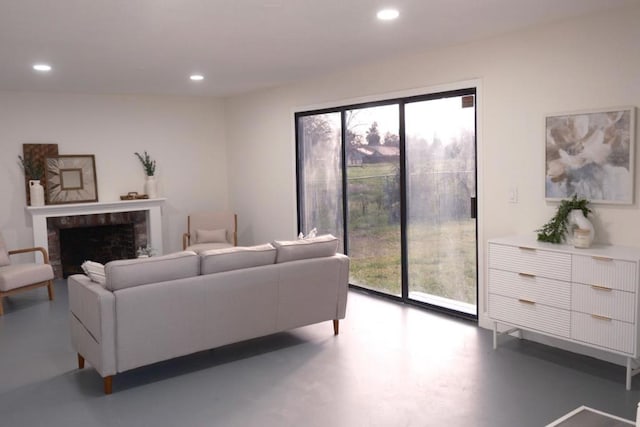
[489,269,571,310]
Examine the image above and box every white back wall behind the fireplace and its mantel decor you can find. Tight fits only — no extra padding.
[0,92,228,252]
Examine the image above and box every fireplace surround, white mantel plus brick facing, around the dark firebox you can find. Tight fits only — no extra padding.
[26,198,166,278]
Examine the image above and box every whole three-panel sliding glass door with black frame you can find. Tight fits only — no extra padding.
[295,89,477,316]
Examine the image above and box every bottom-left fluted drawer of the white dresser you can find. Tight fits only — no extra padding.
[489,294,571,338]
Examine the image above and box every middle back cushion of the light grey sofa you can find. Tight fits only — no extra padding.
[200,243,276,274]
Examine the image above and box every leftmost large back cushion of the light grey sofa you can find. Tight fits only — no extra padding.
[105,251,200,291]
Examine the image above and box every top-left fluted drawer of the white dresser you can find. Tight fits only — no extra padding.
[489,244,571,282]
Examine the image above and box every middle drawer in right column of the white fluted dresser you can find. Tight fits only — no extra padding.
[571,283,636,323]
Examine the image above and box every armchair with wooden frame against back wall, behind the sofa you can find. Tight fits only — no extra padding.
[182,212,238,252]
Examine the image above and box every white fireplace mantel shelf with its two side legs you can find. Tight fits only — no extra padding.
[26,198,167,260]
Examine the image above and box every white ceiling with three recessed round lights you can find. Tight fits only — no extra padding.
[0,0,638,96]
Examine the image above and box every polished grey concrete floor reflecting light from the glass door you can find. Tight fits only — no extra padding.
[0,281,640,427]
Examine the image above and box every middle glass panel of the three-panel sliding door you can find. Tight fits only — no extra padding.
[345,104,402,297]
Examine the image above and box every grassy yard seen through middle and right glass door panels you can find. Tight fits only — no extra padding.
[347,163,477,304]
